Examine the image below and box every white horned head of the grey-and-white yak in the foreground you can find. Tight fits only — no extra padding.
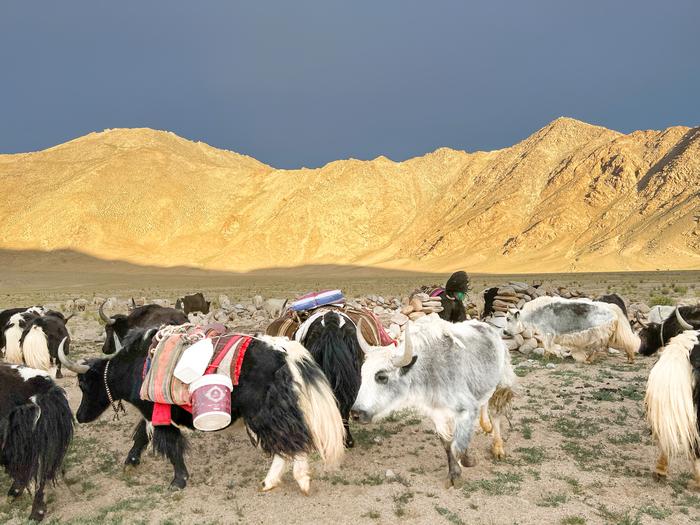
[351,320,418,423]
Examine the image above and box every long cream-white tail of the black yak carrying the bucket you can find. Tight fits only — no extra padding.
[284,341,345,468]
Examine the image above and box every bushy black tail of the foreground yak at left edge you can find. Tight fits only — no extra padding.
[0,385,73,486]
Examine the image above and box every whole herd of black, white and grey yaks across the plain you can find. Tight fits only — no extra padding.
[0,288,700,520]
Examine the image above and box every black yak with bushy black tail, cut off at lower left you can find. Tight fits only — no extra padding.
[0,364,73,521]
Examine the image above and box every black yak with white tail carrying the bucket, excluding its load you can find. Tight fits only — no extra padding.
[59,328,345,494]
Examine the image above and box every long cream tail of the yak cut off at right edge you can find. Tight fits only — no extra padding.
[644,331,700,458]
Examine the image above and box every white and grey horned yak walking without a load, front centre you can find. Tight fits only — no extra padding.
[352,314,515,486]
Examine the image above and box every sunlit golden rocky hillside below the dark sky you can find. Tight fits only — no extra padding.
[0,118,700,272]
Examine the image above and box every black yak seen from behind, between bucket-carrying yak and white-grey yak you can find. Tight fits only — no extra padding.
[295,311,363,447]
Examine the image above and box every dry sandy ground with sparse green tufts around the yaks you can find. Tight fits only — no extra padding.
[0,272,700,525]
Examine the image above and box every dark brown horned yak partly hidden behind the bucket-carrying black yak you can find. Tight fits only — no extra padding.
[99,301,188,354]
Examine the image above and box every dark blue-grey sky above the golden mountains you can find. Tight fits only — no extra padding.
[0,0,700,167]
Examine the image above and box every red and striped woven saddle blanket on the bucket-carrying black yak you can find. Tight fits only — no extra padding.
[140,325,251,408]
